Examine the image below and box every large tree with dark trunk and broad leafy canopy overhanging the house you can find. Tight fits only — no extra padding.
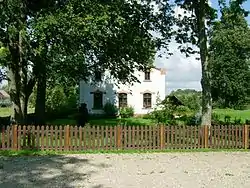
[32,0,175,125]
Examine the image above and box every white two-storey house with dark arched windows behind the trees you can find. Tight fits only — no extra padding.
[80,68,166,115]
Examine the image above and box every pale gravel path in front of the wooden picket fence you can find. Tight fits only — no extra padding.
[0,152,250,188]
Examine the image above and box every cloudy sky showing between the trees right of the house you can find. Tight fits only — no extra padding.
[160,0,250,94]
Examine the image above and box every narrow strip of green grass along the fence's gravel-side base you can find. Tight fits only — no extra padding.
[0,149,249,157]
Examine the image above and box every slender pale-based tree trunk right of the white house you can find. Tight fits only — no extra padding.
[198,0,212,127]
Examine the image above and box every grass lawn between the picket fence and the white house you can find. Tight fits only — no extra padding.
[48,117,155,125]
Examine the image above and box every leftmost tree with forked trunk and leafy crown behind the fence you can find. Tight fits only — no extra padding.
[0,0,67,124]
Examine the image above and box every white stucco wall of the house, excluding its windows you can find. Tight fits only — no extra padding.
[80,69,165,114]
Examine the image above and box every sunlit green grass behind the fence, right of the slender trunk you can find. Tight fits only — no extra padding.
[213,109,250,122]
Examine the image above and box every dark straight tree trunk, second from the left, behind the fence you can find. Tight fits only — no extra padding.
[35,62,46,125]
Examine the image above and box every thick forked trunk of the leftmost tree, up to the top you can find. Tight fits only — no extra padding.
[4,1,35,124]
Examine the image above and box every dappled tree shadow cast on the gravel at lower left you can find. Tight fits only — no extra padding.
[0,150,110,188]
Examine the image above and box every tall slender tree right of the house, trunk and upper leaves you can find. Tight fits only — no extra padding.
[176,0,215,126]
